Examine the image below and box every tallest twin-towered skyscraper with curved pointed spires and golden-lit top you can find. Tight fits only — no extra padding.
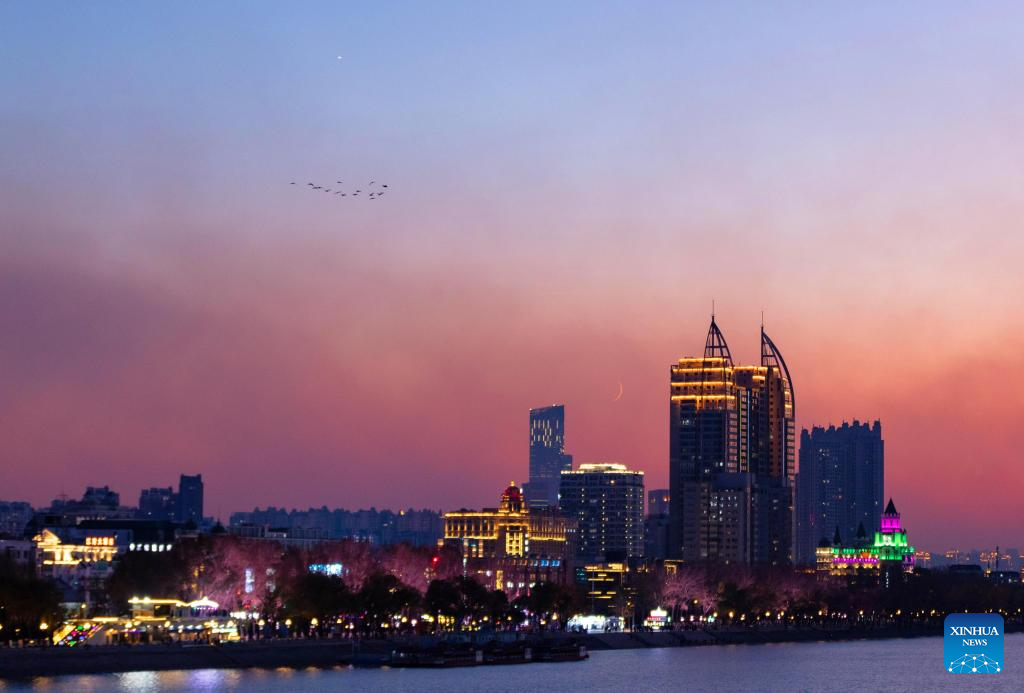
[669,315,796,564]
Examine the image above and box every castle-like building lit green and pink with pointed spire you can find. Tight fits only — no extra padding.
[815,499,915,587]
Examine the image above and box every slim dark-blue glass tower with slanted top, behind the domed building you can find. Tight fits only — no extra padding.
[523,404,572,508]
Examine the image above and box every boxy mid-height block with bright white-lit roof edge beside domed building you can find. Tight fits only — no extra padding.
[561,464,643,561]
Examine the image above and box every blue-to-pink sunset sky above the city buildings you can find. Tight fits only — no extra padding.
[0,3,1024,547]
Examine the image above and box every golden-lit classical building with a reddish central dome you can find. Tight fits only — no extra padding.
[438,482,575,594]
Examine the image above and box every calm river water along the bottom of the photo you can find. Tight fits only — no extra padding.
[0,634,1024,693]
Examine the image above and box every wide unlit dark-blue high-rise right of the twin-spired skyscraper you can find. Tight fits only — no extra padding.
[797,421,885,564]
